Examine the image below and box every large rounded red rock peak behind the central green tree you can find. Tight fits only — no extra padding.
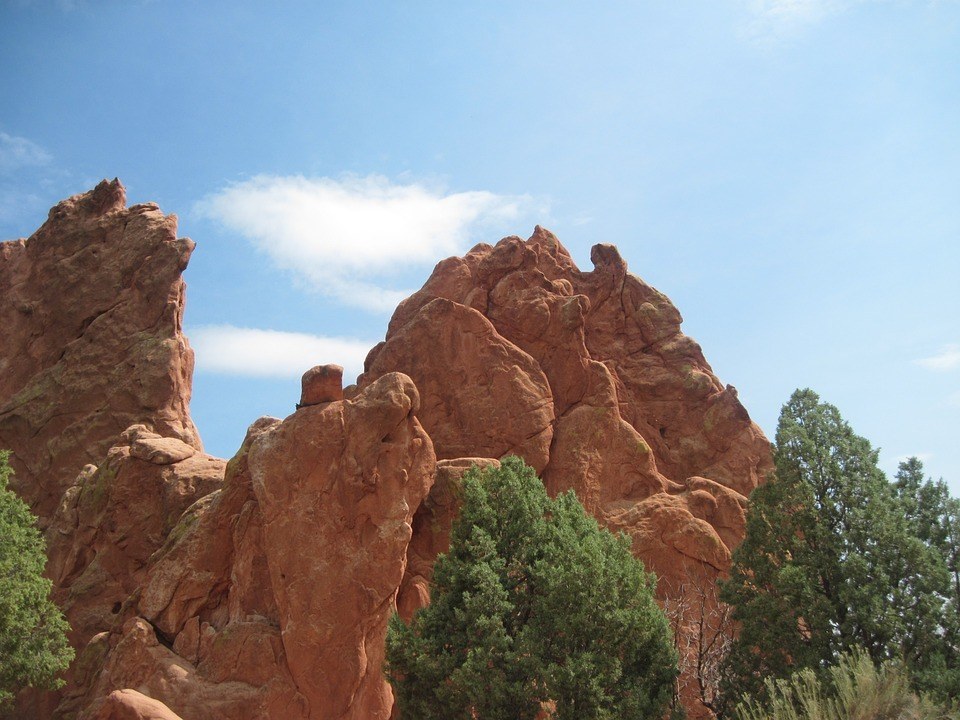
[358,227,772,715]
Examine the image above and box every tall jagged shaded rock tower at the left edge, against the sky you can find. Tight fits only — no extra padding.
[0,180,201,526]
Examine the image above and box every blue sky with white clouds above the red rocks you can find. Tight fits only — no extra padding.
[0,0,960,494]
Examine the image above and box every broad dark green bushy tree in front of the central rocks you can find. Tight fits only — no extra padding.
[387,458,677,720]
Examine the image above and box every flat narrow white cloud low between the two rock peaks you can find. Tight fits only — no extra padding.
[189,325,375,382]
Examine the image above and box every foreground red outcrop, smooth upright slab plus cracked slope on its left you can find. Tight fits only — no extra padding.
[69,373,436,720]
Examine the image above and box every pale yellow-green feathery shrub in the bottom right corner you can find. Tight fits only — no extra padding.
[736,649,955,720]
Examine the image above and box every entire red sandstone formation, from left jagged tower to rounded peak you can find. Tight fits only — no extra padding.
[0,187,770,720]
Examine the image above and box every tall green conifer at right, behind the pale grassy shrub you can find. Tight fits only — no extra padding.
[721,390,948,710]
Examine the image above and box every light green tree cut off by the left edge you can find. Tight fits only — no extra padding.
[0,451,73,705]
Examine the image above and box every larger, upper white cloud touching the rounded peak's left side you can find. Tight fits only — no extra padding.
[197,175,531,310]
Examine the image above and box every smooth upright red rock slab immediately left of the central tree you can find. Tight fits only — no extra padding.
[250,373,435,720]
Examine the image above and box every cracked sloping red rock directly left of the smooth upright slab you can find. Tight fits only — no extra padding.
[73,418,307,720]
